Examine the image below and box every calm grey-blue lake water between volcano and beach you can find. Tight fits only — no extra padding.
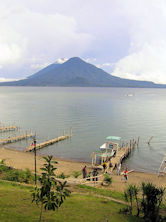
[0,87,166,172]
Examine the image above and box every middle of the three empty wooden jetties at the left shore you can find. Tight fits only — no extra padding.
[0,132,35,145]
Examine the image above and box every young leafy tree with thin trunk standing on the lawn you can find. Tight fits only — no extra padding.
[32,156,70,221]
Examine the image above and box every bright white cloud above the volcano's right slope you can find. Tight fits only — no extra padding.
[112,0,166,83]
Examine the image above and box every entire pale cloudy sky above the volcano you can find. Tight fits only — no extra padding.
[0,0,166,84]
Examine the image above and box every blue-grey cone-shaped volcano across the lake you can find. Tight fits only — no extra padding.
[0,57,166,88]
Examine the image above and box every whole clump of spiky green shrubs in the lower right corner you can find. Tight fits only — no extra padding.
[121,183,166,222]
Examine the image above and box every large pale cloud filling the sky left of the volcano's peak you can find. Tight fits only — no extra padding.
[0,1,93,77]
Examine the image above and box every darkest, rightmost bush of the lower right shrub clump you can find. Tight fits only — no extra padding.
[141,183,165,222]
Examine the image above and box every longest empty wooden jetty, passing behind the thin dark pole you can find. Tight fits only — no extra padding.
[24,129,73,152]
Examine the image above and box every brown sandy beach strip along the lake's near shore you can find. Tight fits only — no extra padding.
[0,147,166,192]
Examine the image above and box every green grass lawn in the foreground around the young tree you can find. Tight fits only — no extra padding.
[0,181,141,222]
